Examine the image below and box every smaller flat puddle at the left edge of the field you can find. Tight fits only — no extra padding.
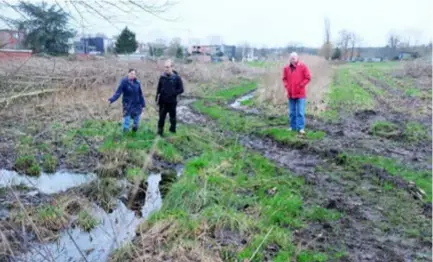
[0,169,96,194]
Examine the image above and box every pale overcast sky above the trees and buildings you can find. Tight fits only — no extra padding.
[0,0,433,47]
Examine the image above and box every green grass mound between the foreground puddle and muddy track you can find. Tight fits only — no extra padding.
[128,139,338,261]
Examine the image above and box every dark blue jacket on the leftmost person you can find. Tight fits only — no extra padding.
[108,77,146,116]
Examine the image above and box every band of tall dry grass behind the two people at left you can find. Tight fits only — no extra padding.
[0,57,261,105]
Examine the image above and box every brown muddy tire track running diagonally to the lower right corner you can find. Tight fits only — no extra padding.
[176,97,431,261]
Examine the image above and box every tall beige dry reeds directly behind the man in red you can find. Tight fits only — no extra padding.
[257,55,332,114]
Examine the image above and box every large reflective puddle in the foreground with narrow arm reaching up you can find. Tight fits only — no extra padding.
[17,174,162,262]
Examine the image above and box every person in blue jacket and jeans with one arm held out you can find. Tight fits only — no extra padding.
[108,69,146,132]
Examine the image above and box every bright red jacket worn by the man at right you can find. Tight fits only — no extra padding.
[283,62,311,98]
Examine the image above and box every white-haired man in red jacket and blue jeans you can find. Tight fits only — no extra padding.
[283,52,311,134]
